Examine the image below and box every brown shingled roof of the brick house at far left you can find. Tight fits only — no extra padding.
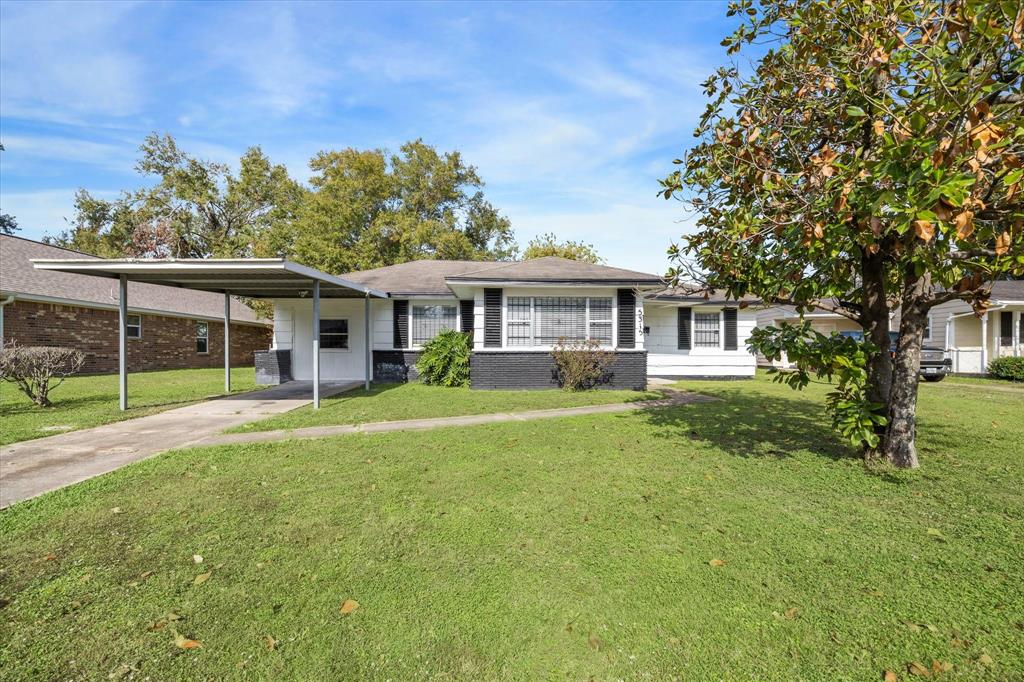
[0,235,269,325]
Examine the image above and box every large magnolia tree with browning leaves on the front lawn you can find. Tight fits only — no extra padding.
[662,0,1024,467]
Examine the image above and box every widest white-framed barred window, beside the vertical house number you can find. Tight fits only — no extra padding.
[506,296,611,346]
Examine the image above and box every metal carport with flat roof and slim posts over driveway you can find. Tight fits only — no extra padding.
[32,258,387,410]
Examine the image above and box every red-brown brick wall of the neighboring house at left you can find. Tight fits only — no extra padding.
[3,301,271,374]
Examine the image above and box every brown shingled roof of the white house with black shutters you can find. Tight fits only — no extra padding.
[341,256,663,296]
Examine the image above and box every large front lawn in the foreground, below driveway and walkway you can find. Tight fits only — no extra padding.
[0,378,1024,680]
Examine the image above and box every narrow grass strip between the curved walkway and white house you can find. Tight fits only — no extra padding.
[230,383,662,433]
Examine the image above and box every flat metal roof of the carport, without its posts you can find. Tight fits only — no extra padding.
[32,258,387,298]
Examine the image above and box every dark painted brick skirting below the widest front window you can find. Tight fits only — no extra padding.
[469,350,647,390]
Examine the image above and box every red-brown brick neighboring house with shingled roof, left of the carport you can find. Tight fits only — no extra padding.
[0,236,272,374]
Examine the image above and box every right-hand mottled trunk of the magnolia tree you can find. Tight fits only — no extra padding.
[882,273,931,469]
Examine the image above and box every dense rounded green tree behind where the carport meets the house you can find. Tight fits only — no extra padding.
[281,140,517,272]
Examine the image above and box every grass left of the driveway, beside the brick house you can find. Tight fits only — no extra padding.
[0,367,256,445]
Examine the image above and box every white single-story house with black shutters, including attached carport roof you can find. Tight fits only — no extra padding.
[29,251,755,401]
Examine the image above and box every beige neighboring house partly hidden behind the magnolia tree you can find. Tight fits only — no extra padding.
[757,281,1024,375]
